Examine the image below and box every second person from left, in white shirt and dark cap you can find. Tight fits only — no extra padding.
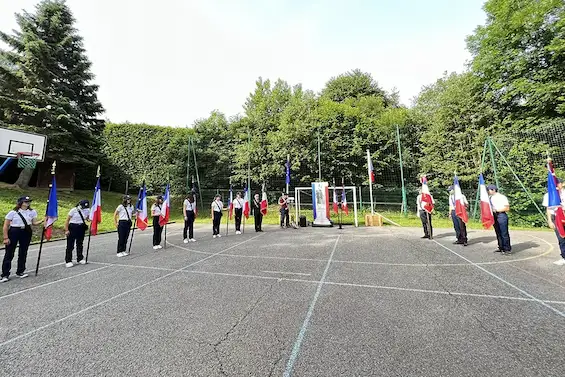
[65,199,90,267]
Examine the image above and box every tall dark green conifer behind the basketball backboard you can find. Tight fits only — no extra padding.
[0,0,104,187]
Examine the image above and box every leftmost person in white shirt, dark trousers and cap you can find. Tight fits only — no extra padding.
[0,196,44,283]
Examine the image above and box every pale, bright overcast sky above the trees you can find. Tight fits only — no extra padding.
[0,0,485,126]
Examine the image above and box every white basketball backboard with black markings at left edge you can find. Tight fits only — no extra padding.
[0,128,47,161]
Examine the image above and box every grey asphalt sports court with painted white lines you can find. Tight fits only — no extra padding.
[0,225,565,376]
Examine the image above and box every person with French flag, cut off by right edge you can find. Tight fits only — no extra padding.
[542,159,565,266]
